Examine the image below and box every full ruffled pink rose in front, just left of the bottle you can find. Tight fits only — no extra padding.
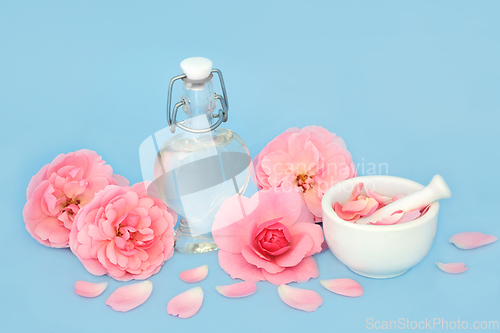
[69,183,177,281]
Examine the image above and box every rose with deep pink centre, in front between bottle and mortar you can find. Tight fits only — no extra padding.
[212,188,324,285]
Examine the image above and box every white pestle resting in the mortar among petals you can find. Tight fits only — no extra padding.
[356,175,451,224]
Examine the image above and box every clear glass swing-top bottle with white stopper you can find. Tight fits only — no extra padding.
[153,57,251,253]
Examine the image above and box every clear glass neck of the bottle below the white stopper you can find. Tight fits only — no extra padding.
[182,80,215,129]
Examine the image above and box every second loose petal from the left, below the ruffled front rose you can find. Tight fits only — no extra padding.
[106,281,153,312]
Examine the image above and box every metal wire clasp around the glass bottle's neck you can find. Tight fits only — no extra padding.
[167,68,229,133]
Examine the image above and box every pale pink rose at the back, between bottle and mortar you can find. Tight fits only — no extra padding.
[253,126,357,221]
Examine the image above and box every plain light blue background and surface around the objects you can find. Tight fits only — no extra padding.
[0,0,500,332]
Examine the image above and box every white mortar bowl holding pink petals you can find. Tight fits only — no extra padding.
[321,176,439,279]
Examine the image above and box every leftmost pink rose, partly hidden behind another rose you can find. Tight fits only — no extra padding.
[23,149,128,248]
